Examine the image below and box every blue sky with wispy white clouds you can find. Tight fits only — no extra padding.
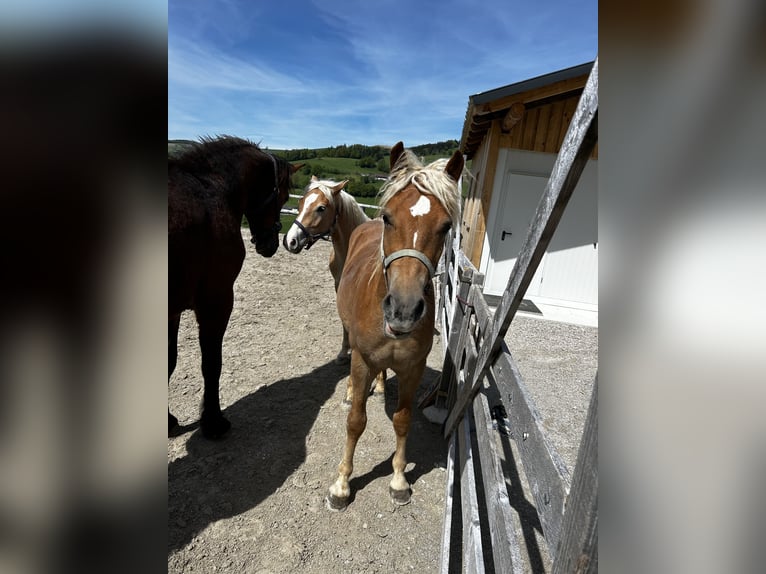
[168,0,598,149]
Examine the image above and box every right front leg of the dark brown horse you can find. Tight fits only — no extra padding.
[197,292,234,439]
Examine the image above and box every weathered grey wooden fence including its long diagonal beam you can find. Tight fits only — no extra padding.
[420,60,598,573]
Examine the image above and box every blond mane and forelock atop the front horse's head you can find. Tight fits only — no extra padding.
[378,149,460,226]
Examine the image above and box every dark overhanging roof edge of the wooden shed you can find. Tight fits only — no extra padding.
[460,62,593,159]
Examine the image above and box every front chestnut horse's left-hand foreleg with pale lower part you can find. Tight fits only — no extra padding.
[327,351,374,510]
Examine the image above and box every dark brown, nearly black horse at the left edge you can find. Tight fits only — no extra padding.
[168,137,297,438]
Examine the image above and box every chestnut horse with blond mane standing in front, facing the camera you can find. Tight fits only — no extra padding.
[327,142,463,510]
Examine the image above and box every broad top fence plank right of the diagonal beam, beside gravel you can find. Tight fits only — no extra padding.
[489,342,570,556]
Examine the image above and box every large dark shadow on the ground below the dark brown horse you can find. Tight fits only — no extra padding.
[168,362,348,552]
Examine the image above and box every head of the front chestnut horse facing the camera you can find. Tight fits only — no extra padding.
[381,142,464,339]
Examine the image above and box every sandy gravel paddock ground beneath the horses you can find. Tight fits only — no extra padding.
[168,232,597,574]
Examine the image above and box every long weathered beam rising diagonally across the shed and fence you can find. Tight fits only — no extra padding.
[445,60,598,435]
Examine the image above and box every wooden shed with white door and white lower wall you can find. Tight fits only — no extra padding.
[460,62,598,325]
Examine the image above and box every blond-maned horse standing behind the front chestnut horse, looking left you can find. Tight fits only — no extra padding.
[282,180,386,404]
